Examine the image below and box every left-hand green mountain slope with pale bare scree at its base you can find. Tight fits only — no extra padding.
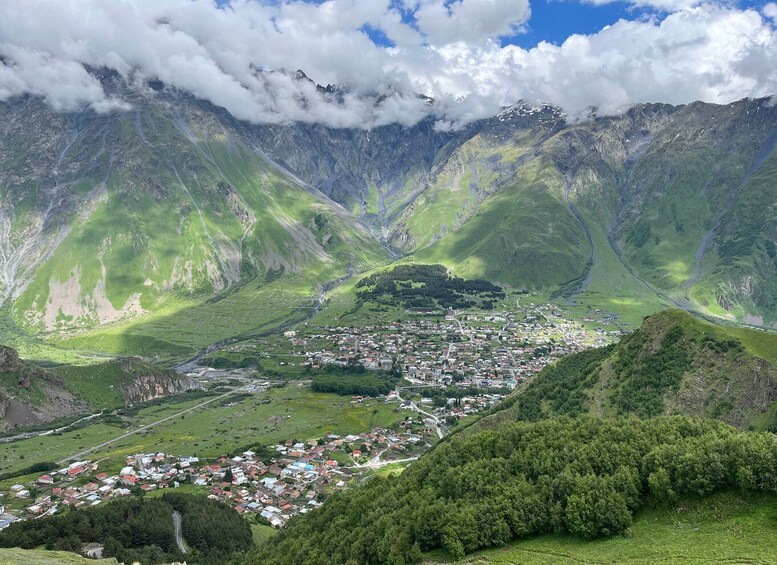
[0,91,386,360]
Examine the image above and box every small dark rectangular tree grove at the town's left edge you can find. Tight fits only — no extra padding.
[310,363,402,396]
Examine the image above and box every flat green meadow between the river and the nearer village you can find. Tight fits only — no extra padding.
[0,382,404,474]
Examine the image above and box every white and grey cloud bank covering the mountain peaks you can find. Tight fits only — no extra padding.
[0,0,777,129]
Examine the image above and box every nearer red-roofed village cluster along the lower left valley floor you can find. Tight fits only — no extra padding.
[0,424,433,529]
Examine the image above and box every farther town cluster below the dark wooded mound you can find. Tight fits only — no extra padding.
[285,304,621,389]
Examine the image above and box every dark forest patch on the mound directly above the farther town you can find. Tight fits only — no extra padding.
[356,265,505,309]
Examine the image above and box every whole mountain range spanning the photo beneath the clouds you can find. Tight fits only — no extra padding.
[0,70,777,356]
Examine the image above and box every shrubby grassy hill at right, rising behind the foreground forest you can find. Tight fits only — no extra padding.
[511,310,777,430]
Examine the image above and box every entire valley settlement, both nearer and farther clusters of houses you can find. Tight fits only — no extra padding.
[0,304,620,529]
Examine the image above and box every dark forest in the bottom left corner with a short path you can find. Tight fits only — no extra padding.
[0,492,252,565]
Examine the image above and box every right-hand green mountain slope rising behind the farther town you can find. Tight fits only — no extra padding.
[274,99,777,326]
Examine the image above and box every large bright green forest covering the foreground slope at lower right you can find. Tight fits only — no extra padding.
[251,416,777,564]
